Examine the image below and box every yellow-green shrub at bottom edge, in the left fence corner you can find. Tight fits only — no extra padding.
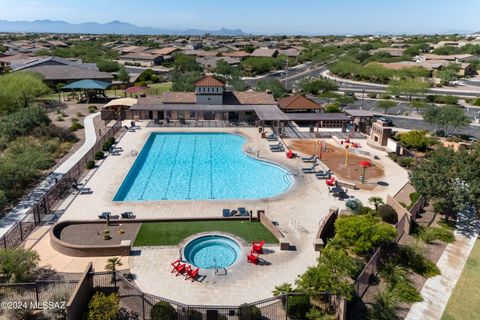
[87,291,120,320]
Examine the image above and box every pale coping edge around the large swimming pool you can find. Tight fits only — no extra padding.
[110,130,302,205]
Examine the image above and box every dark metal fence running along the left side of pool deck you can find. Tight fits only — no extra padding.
[0,122,122,249]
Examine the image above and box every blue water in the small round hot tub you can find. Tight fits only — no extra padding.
[183,236,242,269]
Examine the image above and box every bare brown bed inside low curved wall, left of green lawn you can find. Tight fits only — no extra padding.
[60,223,141,246]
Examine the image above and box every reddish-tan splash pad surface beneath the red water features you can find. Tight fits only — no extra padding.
[288,140,384,189]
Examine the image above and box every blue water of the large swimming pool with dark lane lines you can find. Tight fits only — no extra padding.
[113,133,292,201]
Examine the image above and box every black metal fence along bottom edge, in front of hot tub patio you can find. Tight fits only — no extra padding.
[90,272,345,320]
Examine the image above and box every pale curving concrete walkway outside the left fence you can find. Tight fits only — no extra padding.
[0,112,100,236]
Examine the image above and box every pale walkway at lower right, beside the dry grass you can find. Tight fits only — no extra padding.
[405,212,480,320]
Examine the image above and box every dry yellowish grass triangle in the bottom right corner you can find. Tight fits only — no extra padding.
[442,240,480,320]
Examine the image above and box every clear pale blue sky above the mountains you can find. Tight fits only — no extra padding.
[0,0,480,34]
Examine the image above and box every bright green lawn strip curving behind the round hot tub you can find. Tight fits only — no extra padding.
[135,221,278,246]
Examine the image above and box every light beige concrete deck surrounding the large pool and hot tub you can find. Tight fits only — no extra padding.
[29,122,408,305]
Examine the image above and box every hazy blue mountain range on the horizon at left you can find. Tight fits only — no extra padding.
[0,20,246,36]
